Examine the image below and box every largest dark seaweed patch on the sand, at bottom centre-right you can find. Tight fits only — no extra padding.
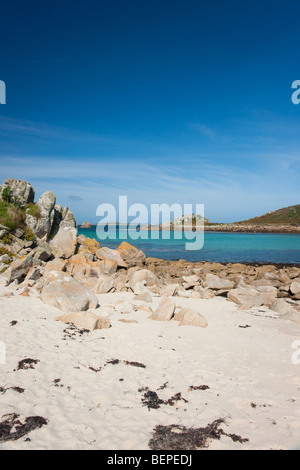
[149,419,249,450]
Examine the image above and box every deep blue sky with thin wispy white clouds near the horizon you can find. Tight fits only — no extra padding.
[0,0,300,222]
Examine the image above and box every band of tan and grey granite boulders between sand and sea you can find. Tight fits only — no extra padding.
[0,180,300,323]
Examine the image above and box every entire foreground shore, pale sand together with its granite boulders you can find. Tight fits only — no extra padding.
[0,180,300,450]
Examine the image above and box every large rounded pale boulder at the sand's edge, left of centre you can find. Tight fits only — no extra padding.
[41,271,98,312]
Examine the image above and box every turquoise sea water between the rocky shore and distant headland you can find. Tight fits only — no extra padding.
[79,227,300,264]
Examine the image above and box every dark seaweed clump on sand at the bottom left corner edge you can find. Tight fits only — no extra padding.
[0,413,48,442]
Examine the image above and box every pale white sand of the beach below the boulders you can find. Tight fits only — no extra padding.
[0,293,300,450]
